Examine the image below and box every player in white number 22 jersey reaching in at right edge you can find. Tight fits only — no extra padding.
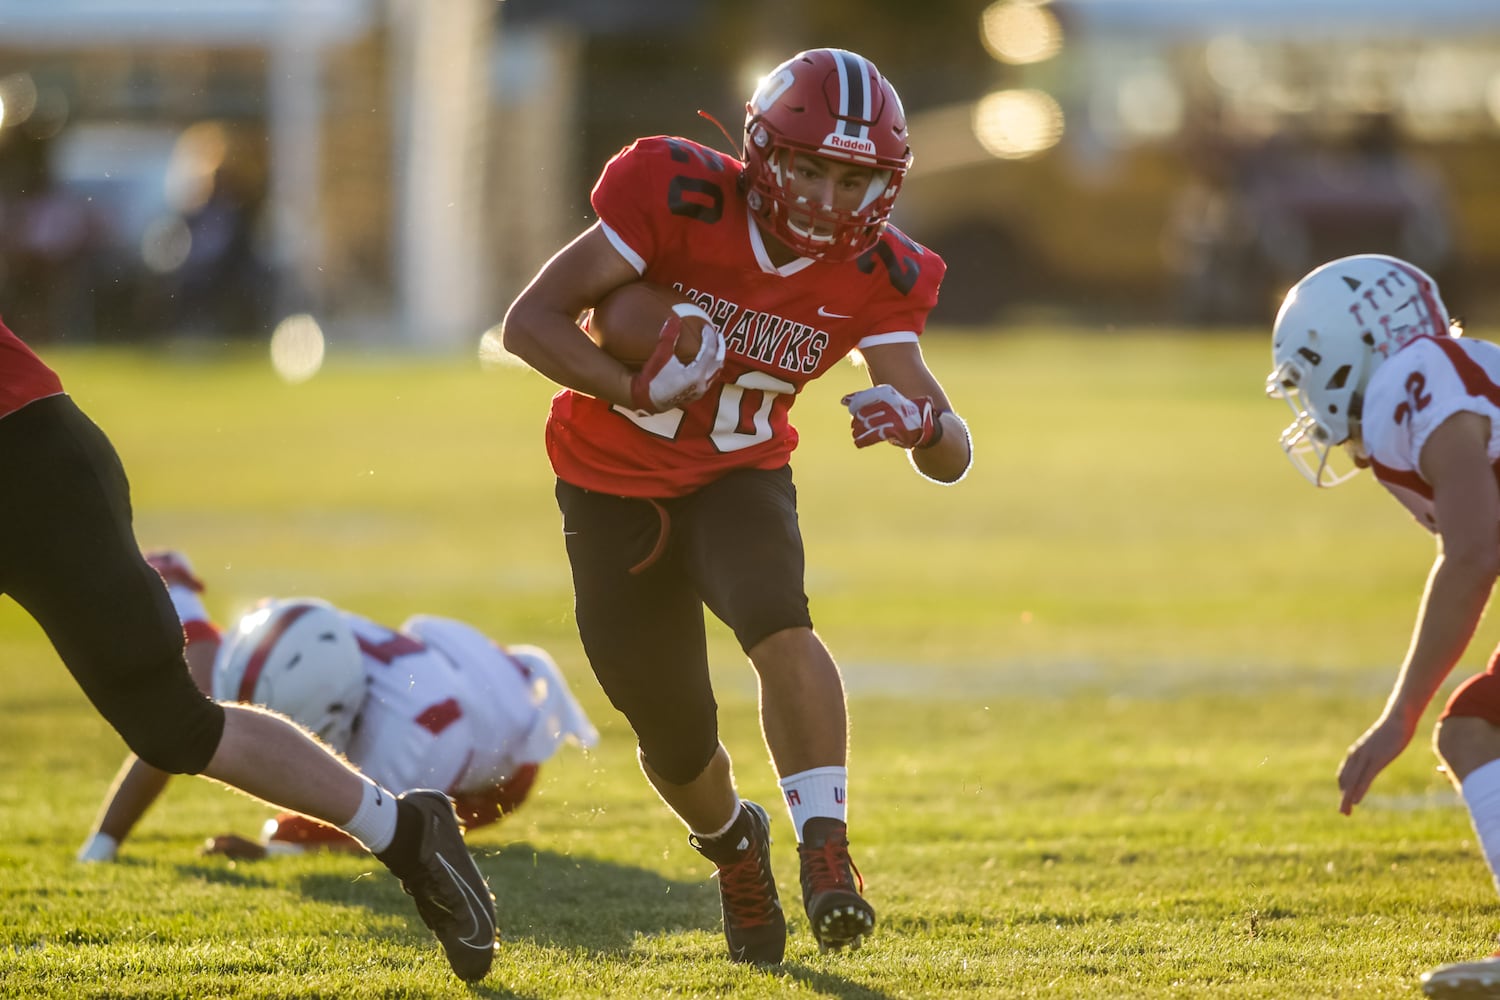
[1266,253,1500,997]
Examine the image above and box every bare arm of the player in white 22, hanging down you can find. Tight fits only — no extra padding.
[1338,411,1500,813]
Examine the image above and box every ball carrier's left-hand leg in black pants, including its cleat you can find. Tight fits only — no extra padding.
[557,483,786,964]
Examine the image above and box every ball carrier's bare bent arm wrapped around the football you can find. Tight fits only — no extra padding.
[503,223,641,406]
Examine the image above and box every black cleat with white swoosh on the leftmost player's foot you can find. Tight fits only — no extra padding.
[395,789,495,982]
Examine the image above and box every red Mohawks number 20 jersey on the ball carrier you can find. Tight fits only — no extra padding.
[546,136,947,496]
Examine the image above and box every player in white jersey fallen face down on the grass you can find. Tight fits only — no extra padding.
[78,550,599,861]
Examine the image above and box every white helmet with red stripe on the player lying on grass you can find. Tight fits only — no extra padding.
[213,597,365,750]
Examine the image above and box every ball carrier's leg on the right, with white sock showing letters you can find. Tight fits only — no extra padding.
[681,468,875,949]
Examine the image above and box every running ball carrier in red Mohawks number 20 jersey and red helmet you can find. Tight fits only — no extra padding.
[504,48,971,963]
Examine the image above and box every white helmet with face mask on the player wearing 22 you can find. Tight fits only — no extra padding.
[1266,253,1457,486]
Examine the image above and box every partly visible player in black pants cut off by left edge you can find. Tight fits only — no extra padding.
[0,324,495,981]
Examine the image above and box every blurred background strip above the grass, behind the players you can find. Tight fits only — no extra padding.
[0,0,1500,351]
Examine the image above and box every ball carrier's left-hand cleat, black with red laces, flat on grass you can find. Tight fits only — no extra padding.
[687,801,786,966]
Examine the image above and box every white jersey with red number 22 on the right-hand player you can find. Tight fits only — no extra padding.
[1361,337,1500,532]
